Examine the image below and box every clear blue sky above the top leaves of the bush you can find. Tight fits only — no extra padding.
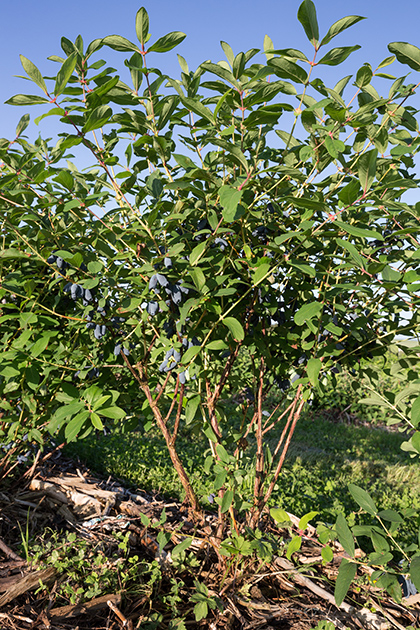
[0,0,420,143]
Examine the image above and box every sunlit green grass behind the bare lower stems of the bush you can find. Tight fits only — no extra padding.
[67,410,420,542]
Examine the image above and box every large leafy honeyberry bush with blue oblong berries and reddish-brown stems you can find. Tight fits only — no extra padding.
[0,0,420,536]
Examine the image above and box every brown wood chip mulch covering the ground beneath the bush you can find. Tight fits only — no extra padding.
[0,450,420,630]
